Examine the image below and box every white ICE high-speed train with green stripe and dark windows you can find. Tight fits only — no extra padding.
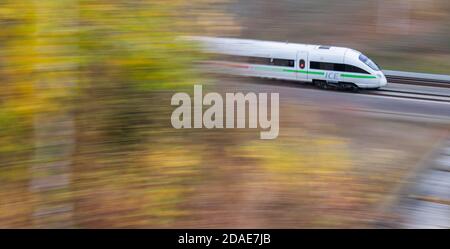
[193,37,387,90]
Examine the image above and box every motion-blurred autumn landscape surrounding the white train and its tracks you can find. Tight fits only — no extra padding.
[0,0,450,228]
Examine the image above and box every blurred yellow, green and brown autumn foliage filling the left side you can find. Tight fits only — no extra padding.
[0,0,234,227]
